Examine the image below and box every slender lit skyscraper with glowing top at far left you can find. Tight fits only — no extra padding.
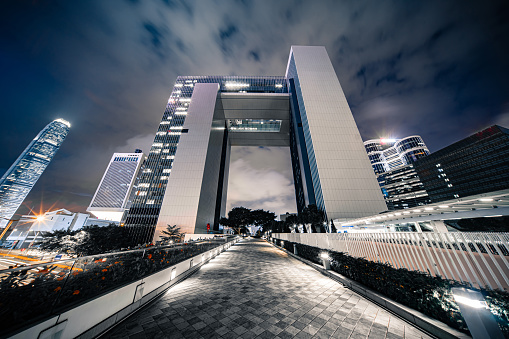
[0,119,71,227]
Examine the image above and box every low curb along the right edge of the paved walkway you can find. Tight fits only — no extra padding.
[267,240,472,339]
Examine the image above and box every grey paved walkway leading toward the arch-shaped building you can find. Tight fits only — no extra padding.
[106,239,429,338]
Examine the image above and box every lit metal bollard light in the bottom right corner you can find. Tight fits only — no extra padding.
[451,287,504,339]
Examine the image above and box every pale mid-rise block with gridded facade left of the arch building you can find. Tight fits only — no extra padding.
[87,149,146,221]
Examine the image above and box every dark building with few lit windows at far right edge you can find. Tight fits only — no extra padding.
[414,125,509,202]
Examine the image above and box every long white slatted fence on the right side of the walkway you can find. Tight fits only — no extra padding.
[272,232,509,290]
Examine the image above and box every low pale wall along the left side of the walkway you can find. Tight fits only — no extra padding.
[11,239,238,339]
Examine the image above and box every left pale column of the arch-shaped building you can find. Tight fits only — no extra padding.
[154,84,224,240]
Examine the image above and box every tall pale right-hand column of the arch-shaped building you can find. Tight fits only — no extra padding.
[287,46,385,219]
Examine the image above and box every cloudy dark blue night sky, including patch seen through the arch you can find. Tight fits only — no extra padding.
[0,0,509,219]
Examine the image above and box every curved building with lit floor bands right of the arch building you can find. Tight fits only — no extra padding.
[364,135,431,210]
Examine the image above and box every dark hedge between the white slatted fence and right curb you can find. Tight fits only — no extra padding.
[276,239,509,337]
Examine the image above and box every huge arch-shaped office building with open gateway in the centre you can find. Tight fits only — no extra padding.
[126,46,385,243]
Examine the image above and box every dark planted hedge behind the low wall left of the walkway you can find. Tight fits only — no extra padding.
[0,241,224,338]
